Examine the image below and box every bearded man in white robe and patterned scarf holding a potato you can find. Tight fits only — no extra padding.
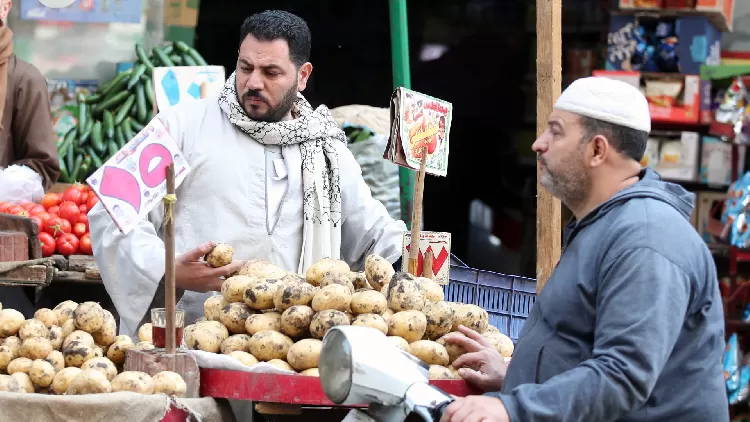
[89,11,406,335]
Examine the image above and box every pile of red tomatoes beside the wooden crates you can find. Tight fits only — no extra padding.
[0,184,99,256]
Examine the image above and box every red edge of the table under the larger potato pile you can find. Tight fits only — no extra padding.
[200,368,482,406]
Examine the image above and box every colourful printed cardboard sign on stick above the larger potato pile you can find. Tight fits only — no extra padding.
[383,87,453,176]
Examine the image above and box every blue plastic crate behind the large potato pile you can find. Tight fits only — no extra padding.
[445,265,536,343]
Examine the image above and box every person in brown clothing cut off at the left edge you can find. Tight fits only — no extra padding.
[0,0,60,191]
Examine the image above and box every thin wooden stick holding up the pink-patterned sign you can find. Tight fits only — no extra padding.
[164,164,177,355]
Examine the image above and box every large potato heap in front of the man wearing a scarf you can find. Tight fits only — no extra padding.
[167,255,513,379]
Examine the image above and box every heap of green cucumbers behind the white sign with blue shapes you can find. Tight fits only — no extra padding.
[57,41,206,183]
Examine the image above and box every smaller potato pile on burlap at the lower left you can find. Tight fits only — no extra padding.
[0,300,187,397]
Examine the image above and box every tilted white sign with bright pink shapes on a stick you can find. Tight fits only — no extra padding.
[86,119,190,234]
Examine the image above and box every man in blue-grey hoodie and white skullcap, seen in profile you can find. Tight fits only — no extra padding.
[442,78,729,422]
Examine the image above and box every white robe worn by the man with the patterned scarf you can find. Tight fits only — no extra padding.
[89,97,406,336]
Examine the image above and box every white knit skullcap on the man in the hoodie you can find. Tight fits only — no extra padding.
[554,76,651,132]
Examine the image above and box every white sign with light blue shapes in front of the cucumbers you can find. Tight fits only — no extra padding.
[153,66,226,111]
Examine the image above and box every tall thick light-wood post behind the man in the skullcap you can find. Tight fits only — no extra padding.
[536,0,562,293]
